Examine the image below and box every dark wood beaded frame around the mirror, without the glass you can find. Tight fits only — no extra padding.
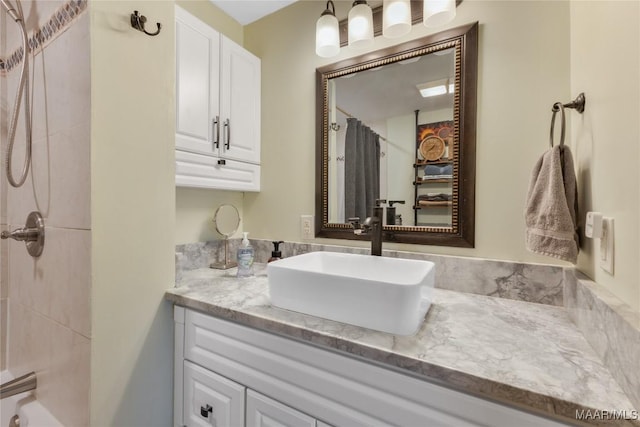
[315,22,478,247]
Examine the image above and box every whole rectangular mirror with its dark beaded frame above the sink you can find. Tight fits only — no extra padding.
[316,22,478,247]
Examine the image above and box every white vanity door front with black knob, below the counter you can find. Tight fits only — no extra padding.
[183,361,245,427]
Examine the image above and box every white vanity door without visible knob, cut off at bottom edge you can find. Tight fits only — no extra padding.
[247,390,316,427]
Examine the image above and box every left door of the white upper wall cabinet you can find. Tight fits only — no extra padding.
[176,7,220,155]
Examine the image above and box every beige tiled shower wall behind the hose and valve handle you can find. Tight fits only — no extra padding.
[0,0,91,426]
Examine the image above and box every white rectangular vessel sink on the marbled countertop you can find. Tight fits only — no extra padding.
[267,252,435,335]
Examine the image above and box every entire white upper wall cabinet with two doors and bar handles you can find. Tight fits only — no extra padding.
[175,6,260,191]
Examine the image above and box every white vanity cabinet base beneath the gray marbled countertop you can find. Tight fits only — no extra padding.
[174,306,563,427]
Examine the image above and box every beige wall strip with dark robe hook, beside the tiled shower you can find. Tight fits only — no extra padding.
[89,0,175,426]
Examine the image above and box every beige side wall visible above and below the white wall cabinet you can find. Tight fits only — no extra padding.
[175,0,246,244]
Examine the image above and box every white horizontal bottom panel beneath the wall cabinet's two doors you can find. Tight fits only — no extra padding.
[176,150,260,191]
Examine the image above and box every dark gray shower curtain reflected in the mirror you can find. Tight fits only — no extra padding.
[344,118,380,220]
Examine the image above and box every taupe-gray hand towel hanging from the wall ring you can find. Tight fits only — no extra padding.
[525,145,579,264]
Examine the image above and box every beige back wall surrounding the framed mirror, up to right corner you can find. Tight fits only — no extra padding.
[244,1,570,256]
